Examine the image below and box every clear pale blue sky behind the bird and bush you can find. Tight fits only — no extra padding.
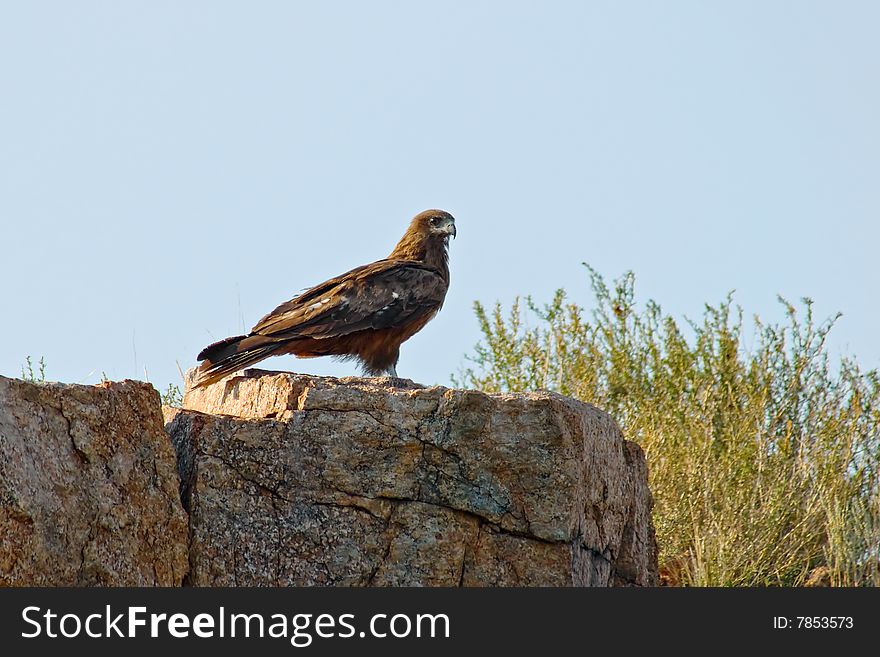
[0,0,880,389]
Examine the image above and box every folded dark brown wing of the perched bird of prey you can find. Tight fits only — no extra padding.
[252,260,447,340]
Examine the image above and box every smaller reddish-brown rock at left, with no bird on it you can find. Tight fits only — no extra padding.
[0,376,187,586]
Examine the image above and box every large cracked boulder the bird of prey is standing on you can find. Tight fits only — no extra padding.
[166,370,658,586]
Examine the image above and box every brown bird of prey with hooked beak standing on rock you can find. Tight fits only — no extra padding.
[193,210,455,388]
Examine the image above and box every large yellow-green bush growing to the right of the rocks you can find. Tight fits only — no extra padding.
[457,267,880,586]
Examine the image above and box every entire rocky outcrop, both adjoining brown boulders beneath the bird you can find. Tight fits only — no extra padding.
[0,370,657,586]
